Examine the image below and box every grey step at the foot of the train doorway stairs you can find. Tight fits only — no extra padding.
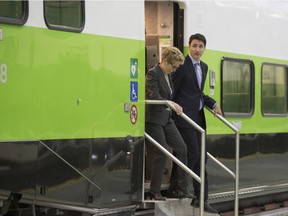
[143,199,219,216]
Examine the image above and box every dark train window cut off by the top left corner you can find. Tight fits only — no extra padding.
[0,0,28,25]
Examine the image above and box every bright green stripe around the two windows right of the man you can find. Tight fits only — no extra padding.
[184,47,288,134]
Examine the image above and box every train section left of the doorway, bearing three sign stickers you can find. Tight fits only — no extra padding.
[0,0,145,215]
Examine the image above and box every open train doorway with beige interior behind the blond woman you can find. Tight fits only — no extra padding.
[145,1,184,183]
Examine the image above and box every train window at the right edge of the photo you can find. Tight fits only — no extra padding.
[261,63,288,116]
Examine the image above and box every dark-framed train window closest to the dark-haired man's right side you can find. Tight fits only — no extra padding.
[221,58,255,116]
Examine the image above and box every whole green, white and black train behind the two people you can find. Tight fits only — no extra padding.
[0,0,288,214]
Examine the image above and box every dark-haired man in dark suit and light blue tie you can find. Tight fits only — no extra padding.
[172,34,222,213]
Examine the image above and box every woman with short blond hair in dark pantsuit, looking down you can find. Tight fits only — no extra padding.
[145,47,187,200]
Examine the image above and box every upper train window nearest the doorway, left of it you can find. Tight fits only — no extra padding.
[44,0,85,32]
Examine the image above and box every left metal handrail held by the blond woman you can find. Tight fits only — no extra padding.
[145,100,206,215]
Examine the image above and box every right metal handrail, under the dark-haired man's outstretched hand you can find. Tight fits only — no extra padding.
[205,107,240,216]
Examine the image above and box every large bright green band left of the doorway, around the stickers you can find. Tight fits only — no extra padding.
[0,25,145,140]
